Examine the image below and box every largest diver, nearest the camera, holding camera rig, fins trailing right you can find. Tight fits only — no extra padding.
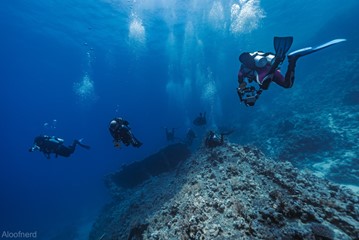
[237,37,346,106]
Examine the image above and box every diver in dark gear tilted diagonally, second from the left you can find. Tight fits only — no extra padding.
[108,117,142,148]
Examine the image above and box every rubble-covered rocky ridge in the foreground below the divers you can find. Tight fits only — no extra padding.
[89,143,359,240]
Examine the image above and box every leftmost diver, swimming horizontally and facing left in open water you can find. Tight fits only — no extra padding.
[29,135,90,159]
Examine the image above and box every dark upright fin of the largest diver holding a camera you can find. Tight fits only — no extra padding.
[267,37,293,76]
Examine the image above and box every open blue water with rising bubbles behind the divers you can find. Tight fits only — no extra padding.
[0,0,359,239]
